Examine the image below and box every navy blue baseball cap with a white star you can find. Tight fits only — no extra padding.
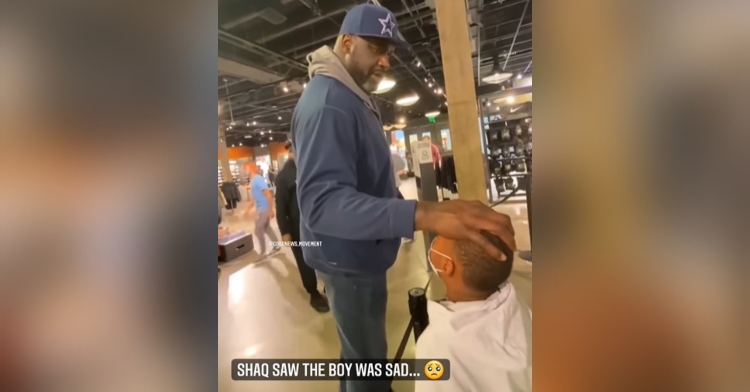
[339,4,406,45]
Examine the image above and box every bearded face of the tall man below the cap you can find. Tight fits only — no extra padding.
[342,35,393,93]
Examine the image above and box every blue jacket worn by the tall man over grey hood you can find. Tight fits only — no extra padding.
[292,47,417,275]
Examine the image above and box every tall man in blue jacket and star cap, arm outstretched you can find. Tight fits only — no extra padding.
[292,4,515,392]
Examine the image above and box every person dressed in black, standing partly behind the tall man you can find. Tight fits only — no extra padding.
[276,143,330,313]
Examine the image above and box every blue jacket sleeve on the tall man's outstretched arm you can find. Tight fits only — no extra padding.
[295,106,417,240]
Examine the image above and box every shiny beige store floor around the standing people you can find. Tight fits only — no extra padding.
[218,179,531,392]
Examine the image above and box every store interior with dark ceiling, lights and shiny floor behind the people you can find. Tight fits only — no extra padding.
[217,0,533,392]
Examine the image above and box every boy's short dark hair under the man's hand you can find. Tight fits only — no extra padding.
[456,231,513,293]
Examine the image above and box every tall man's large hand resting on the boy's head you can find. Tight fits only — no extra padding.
[414,200,516,261]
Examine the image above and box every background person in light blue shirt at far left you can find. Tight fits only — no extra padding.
[245,162,280,257]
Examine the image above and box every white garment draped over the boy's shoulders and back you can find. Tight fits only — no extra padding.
[415,282,531,392]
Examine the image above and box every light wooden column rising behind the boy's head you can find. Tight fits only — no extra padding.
[435,0,487,204]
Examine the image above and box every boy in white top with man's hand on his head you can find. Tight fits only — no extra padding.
[415,232,531,392]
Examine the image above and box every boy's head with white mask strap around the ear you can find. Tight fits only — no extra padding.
[427,231,513,300]
